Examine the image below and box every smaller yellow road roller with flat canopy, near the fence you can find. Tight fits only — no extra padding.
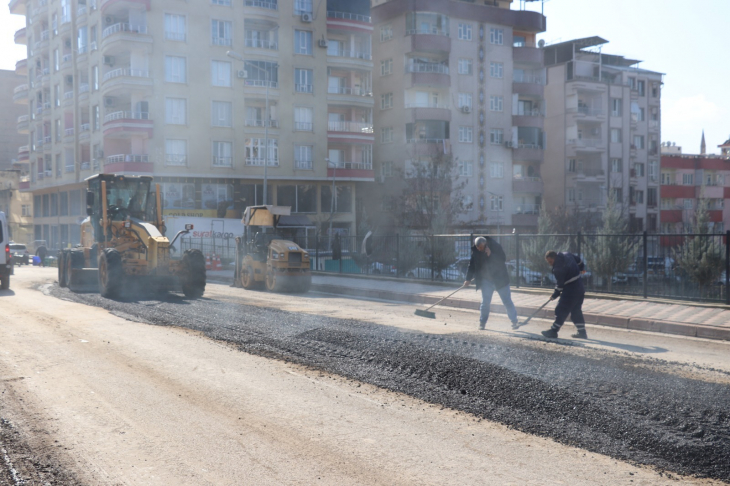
[234,206,312,292]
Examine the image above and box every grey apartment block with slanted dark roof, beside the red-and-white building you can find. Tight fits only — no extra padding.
[542,37,662,231]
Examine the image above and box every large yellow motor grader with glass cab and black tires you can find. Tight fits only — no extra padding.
[58,174,206,298]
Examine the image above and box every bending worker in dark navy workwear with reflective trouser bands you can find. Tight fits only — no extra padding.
[542,250,588,339]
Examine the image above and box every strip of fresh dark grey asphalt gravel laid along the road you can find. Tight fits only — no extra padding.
[51,286,730,482]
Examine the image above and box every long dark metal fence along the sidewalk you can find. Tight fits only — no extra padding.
[181,231,730,304]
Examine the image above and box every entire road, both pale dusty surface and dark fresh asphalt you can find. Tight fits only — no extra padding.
[0,267,730,485]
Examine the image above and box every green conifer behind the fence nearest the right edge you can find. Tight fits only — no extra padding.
[674,199,725,296]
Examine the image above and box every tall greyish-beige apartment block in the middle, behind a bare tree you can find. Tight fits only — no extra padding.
[369,0,545,230]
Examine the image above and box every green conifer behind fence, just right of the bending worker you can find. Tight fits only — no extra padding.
[585,194,640,292]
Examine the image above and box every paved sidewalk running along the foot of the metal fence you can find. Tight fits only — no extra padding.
[208,271,730,341]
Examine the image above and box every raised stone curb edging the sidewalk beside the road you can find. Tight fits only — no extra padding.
[209,277,730,341]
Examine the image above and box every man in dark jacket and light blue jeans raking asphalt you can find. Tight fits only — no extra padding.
[464,236,517,329]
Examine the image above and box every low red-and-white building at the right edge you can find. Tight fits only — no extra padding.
[660,138,730,233]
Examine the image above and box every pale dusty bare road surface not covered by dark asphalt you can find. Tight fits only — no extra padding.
[0,267,729,485]
